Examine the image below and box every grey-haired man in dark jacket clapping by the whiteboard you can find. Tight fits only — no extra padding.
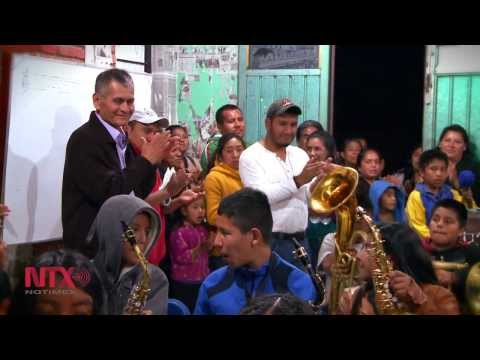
[62,69,172,256]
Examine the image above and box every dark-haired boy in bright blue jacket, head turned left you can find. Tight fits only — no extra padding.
[194,188,317,315]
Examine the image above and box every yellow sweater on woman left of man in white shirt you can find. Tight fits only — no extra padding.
[204,163,243,226]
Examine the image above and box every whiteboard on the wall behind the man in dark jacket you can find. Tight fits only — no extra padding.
[2,55,152,244]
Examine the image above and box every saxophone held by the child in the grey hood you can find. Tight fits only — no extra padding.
[122,221,151,315]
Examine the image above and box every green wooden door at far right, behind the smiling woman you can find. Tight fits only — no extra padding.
[423,45,480,157]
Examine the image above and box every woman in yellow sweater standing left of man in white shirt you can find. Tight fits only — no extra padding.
[204,133,245,270]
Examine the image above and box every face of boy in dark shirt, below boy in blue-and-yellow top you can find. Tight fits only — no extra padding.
[429,207,464,247]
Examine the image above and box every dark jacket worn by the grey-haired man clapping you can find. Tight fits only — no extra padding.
[62,111,155,256]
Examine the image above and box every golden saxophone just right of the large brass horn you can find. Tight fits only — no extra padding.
[357,206,406,315]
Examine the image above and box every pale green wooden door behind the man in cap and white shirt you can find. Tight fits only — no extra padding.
[238,45,330,143]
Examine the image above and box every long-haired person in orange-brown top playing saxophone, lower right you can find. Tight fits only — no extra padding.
[339,224,460,315]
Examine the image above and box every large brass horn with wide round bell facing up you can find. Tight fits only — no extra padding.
[310,167,359,314]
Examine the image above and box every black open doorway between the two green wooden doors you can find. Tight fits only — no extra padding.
[333,46,425,173]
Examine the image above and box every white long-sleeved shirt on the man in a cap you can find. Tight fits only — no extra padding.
[239,142,313,234]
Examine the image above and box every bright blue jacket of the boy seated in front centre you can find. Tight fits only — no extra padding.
[194,252,317,315]
